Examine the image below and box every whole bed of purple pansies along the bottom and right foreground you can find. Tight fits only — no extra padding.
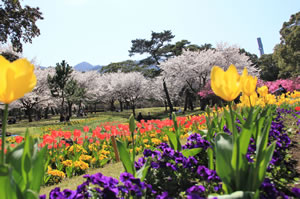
[41,109,300,199]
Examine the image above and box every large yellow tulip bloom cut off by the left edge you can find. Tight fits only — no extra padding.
[0,56,36,104]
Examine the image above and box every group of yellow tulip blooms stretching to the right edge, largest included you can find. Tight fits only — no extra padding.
[211,65,300,106]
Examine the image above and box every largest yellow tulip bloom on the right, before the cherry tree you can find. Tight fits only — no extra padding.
[210,64,244,101]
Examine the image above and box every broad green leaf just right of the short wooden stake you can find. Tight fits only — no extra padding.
[117,140,135,176]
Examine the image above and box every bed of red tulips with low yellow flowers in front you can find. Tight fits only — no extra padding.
[0,115,205,185]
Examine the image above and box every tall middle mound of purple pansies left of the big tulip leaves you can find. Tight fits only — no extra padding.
[135,142,221,198]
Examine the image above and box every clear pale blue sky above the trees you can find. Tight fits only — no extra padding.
[23,0,300,66]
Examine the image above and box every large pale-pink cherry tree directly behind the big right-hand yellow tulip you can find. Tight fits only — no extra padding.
[160,44,259,109]
